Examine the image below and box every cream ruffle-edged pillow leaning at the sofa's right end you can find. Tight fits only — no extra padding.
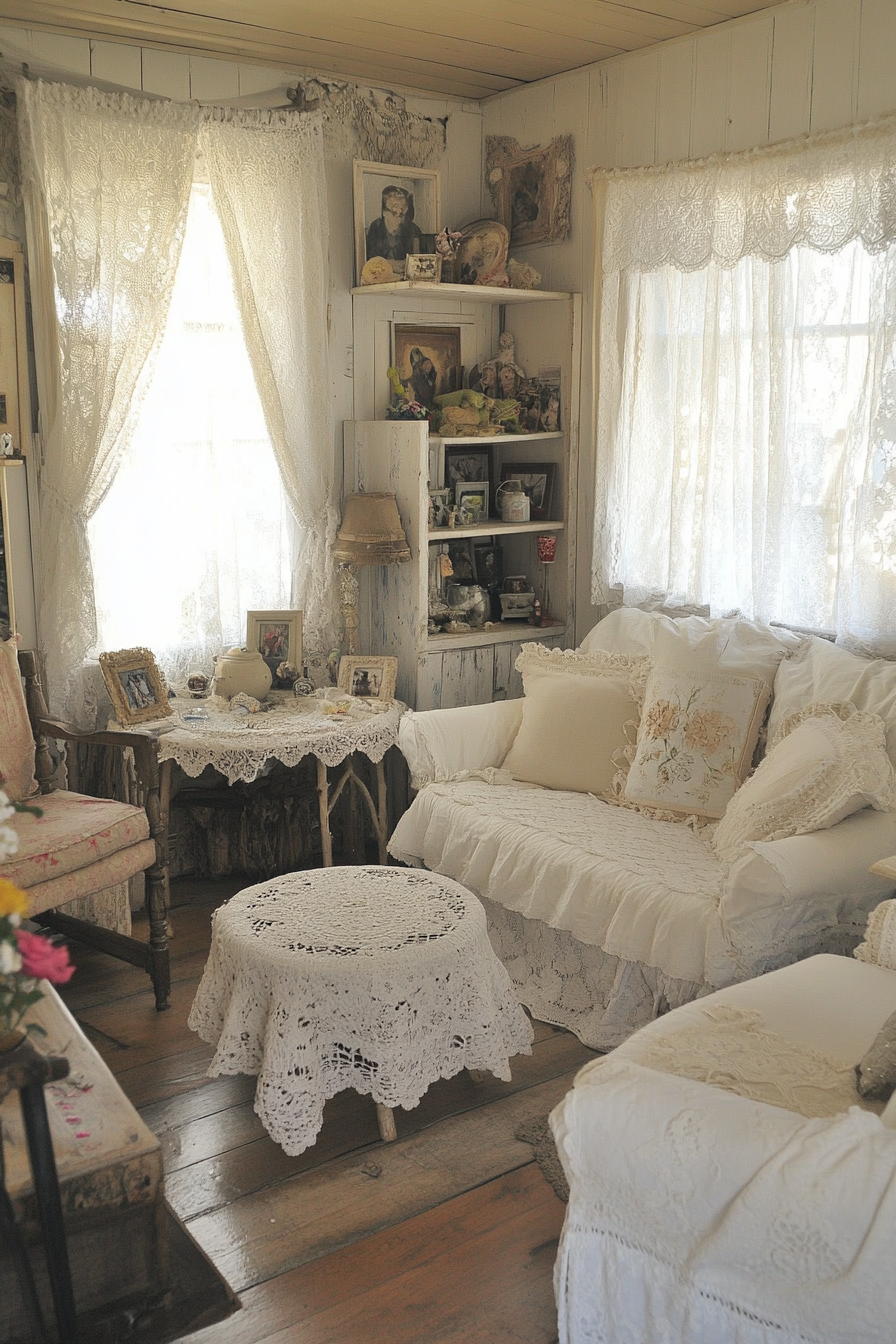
[712,707,896,860]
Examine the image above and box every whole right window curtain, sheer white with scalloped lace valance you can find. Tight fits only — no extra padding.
[591,118,896,653]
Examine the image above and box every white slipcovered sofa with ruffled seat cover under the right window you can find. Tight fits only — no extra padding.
[388,612,896,1050]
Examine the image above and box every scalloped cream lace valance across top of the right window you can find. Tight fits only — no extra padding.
[590,117,896,276]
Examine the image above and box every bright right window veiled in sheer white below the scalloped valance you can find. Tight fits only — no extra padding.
[603,241,896,637]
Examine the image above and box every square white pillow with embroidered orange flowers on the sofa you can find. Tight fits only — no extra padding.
[623,665,770,817]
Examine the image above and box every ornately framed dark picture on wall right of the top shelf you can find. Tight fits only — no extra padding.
[485,136,574,247]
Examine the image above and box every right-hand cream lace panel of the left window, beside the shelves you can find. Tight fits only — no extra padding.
[201,109,339,648]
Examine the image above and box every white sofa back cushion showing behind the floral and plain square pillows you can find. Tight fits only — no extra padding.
[580,606,803,685]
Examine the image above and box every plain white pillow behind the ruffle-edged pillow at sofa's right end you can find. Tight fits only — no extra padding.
[768,636,896,765]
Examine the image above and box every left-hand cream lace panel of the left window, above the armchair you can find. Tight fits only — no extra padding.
[16,81,201,720]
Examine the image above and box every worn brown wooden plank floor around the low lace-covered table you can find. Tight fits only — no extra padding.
[63,879,592,1344]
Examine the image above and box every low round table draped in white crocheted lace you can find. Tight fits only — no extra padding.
[189,867,532,1156]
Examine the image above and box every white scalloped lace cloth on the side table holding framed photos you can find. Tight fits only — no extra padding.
[147,699,407,784]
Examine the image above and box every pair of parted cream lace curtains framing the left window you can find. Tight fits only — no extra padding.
[16,81,339,722]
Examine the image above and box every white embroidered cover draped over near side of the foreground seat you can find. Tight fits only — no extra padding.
[551,1052,896,1344]
